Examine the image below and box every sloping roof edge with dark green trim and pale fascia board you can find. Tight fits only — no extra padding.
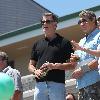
[0,6,100,47]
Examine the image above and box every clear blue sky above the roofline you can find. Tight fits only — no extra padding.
[35,0,100,17]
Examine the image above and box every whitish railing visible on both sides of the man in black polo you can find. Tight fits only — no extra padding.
[21,74,77,100]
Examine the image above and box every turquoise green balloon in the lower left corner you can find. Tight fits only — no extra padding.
[0,72,15,100]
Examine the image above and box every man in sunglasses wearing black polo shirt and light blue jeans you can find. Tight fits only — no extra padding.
[28,13,75,100]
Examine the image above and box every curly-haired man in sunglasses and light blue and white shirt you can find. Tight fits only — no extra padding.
[71,10,100,100]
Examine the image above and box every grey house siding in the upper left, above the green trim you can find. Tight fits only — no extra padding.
[0,0,49,35]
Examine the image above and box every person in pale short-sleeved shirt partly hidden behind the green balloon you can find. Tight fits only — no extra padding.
[0,51,23,100]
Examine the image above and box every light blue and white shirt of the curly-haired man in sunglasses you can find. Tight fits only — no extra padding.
[75,29,100,89]
